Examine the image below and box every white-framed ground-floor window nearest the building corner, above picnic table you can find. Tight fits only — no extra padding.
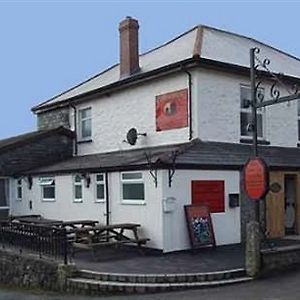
[121,172,145,204]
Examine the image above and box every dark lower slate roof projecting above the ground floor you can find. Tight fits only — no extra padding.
[28,139,300,175]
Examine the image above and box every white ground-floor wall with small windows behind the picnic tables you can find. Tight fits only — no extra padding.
[11,171,162,249]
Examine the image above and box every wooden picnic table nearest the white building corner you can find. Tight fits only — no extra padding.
[71,223,149,250]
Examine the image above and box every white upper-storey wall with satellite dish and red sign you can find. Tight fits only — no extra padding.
[70,72,197,155]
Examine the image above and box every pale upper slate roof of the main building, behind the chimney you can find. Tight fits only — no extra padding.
[32,25,300,111]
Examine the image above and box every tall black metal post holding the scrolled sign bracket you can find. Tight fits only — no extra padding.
[250,48,260,223]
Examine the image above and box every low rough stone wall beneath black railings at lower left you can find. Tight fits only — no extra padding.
[0,249,75,291]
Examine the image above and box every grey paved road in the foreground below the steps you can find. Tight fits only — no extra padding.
[0,270,300,300]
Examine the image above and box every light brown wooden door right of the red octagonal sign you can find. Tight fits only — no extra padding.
[266,172,285,238]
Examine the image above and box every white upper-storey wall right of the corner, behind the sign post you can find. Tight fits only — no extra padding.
[194,70,298,147]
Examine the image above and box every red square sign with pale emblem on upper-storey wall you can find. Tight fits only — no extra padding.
[156,89,188,131]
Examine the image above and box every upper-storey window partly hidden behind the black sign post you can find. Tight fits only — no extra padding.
[240,86,264,139]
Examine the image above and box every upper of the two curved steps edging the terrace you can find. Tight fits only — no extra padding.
[75,268,246,283]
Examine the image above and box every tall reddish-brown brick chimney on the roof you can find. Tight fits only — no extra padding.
[119,17,140,78]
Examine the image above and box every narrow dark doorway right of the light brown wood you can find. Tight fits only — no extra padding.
[284,175,297,235]
